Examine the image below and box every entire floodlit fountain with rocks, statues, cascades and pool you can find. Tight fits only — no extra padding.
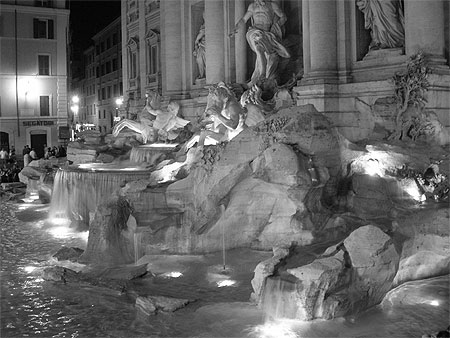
[1,0,450,338]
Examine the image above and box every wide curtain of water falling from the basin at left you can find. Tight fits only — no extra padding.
[49,165,150,224]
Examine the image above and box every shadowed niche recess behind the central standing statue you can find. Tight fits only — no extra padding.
[243,0,303,85]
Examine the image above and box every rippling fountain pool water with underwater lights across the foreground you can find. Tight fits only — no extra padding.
[0,203,449,338]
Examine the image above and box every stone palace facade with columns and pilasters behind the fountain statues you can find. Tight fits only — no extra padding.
[122,0,450,140]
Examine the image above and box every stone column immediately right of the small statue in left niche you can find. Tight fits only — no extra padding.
[205,0,225,84]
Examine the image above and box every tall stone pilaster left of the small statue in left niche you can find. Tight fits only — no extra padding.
[161,0,183,95]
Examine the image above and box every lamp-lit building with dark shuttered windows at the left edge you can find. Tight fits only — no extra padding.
[0,0,69,156]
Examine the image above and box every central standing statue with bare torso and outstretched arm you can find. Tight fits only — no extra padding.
[230,0,291,87]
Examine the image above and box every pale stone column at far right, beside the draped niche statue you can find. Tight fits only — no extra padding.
[405,0,445,57]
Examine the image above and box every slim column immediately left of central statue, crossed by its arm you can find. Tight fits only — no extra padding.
[234,0,247,83]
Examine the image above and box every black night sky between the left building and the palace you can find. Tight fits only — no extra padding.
[70,0,120,51]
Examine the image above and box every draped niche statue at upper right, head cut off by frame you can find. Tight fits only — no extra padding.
[356,0,405,50]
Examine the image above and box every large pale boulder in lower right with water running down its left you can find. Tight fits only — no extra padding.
[265,225,399,320]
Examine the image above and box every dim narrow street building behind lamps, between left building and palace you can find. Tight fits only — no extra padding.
[71,18,123,134]
